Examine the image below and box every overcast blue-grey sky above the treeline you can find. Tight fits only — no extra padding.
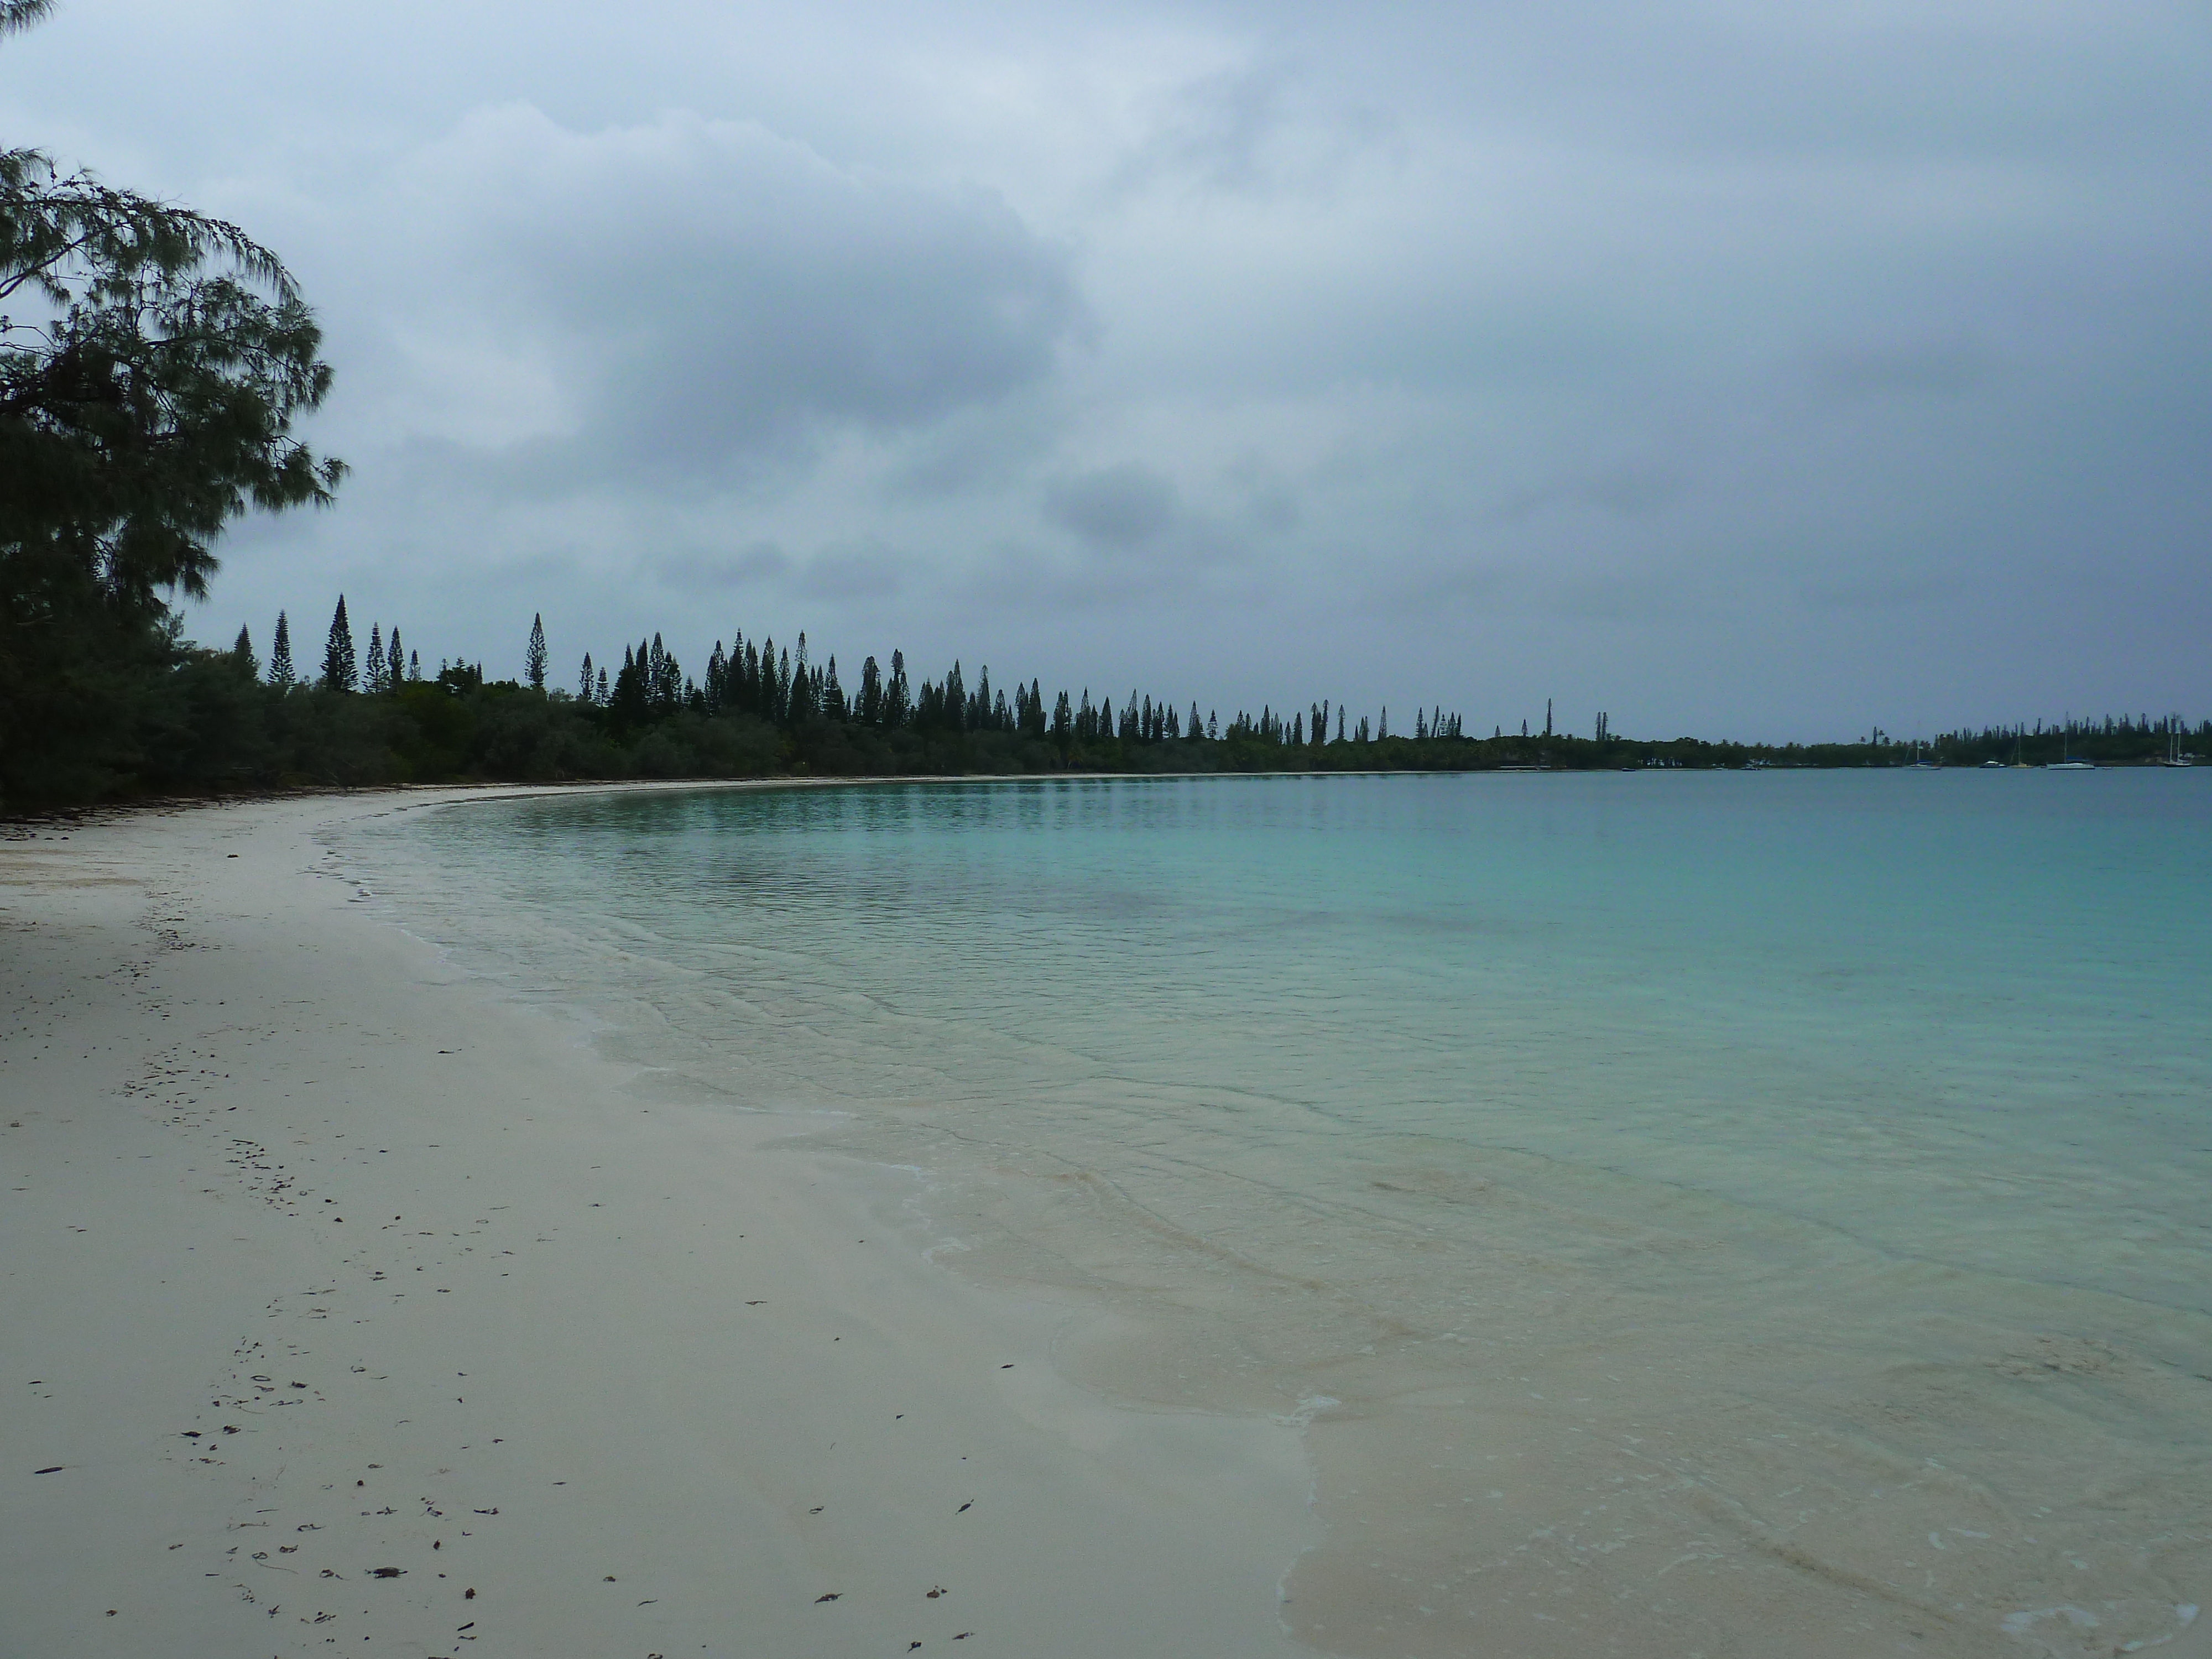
[0,0,2212,739]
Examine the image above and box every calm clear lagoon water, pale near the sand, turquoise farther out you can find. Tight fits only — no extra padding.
[341,772,2212,1655]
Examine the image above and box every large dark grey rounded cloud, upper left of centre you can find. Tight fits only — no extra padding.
[394,106,1082,480]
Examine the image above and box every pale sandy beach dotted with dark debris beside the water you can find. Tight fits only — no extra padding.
[0,796,1316,1659]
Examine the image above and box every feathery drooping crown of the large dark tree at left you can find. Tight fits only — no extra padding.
[0,150,345,604]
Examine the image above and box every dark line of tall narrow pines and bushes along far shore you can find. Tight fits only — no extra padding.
[13,597,2212,812]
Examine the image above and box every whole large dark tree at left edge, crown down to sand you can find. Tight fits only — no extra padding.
[0,0,345,803]
